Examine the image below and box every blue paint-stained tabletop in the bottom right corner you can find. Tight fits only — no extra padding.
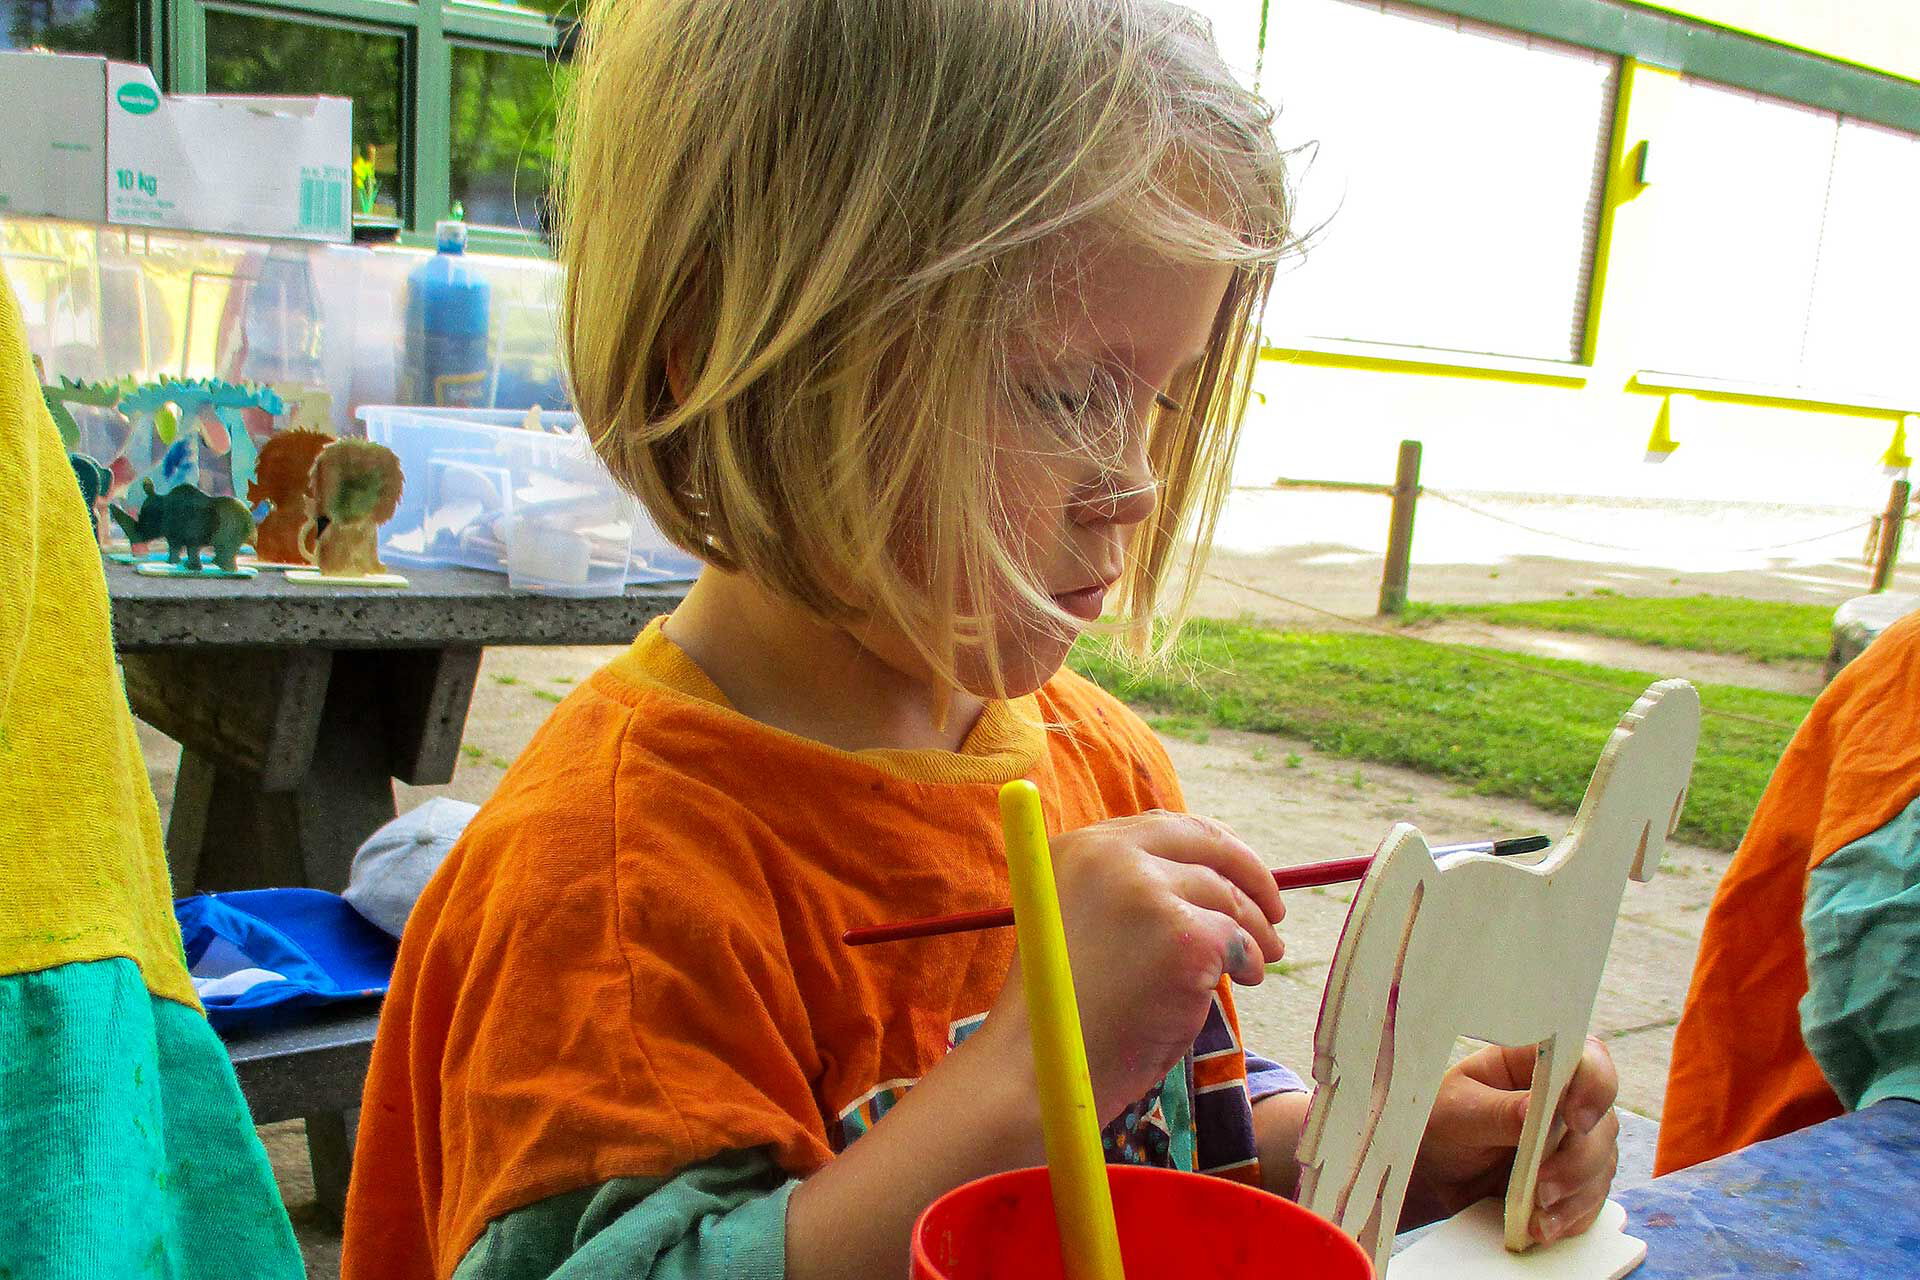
[1617,1102,1920,1280]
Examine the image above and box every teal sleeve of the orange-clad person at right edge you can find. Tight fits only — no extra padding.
[1801,798,1920,1109]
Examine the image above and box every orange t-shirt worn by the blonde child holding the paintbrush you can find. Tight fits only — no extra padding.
[342,624,1258,1280]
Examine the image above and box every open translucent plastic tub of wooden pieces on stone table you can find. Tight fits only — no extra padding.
[359,405,699,595]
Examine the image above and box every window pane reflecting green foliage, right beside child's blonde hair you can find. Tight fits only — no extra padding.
[447,44,568,230]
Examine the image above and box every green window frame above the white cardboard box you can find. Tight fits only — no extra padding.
[161,0,564,253]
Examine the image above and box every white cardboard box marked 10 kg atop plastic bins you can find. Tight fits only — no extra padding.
[0,52,353,244]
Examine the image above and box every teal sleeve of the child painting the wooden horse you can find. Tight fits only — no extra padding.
[453,1148,799,1280]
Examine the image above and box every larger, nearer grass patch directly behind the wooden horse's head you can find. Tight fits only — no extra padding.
[1071,620,1812,848]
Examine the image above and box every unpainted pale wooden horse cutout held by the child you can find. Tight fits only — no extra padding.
[1300,679,1699,1276]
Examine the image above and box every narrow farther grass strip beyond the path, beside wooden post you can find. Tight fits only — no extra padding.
[1405,591,1834,662]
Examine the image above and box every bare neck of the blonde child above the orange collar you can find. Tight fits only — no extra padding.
[666,568,985,750]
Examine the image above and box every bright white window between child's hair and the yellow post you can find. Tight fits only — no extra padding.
[1261,0,1619,361]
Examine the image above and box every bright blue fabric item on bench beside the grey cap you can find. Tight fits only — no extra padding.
[173,889,399,1031]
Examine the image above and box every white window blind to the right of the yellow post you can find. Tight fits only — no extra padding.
[1640,79,1920,399]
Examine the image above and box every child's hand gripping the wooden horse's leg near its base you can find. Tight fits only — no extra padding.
[1402,1038,1620,1244]
